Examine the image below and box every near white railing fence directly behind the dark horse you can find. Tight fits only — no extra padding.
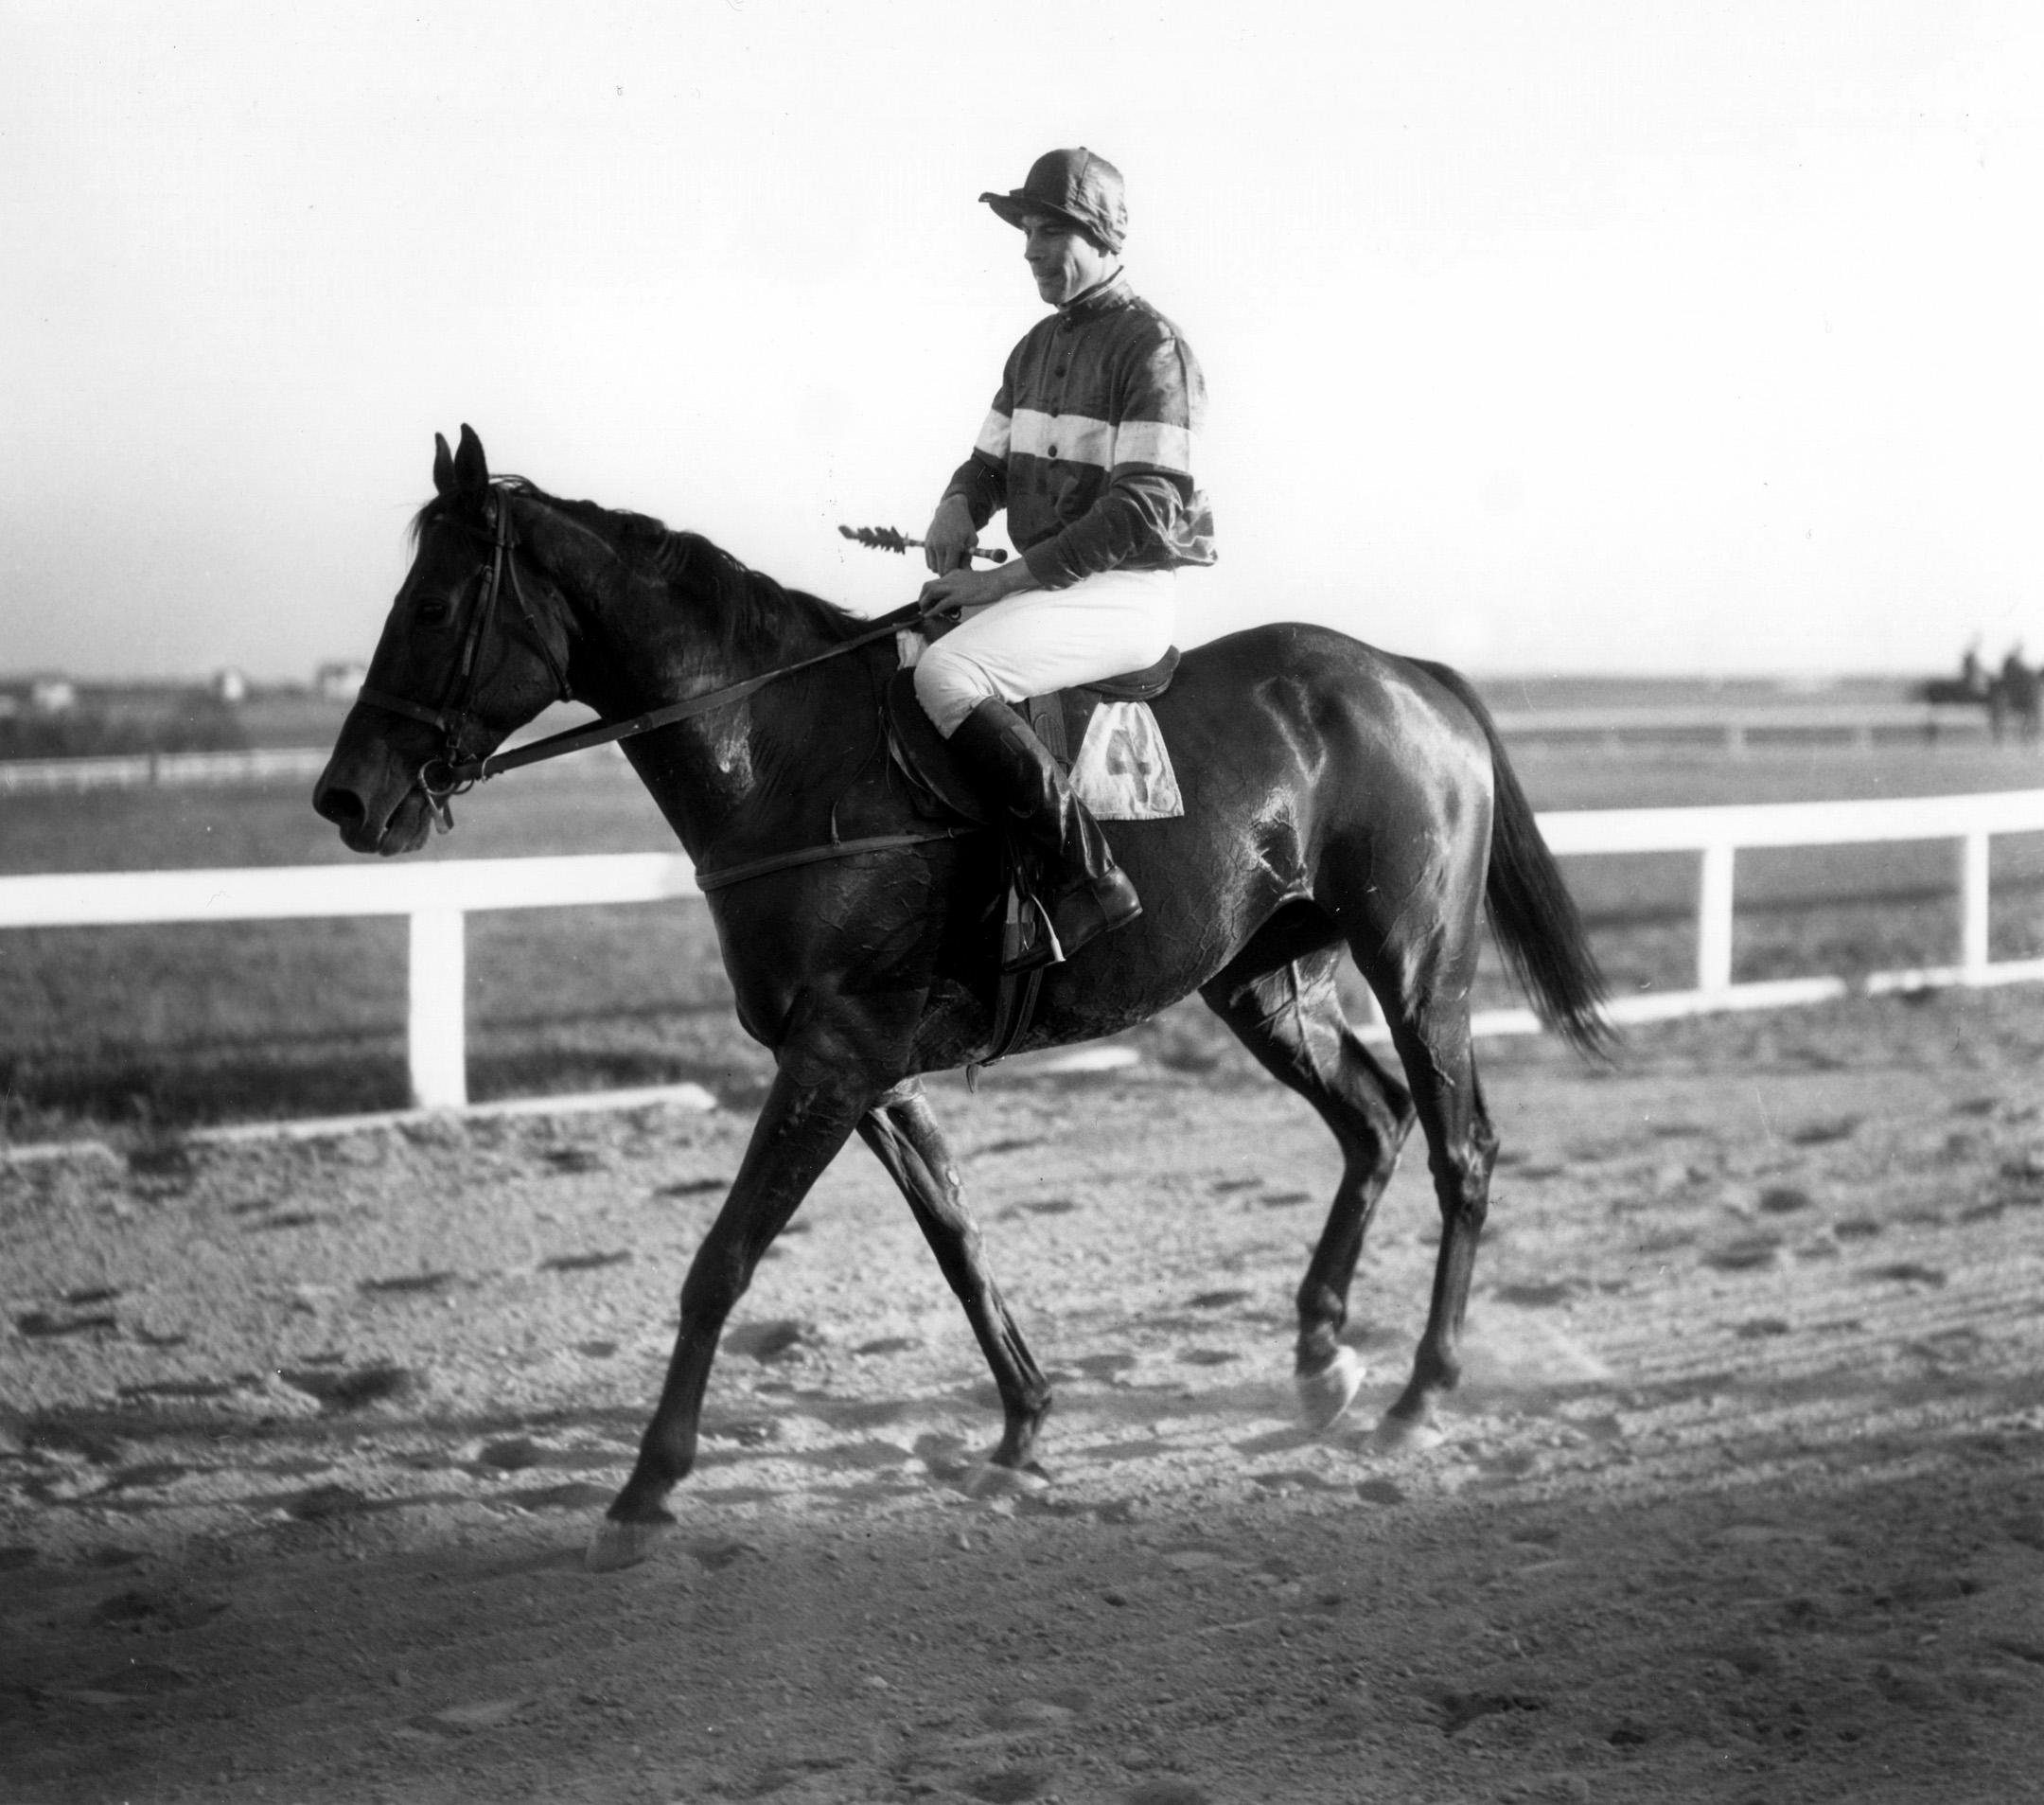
[0,789,2044,1108]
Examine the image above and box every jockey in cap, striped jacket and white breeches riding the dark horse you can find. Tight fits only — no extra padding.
[916,147,1214,964]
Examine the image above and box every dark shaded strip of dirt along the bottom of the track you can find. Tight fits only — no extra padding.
[0,1423,2044,1801]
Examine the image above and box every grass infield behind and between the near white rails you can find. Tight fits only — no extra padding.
[0,719,2044,1141]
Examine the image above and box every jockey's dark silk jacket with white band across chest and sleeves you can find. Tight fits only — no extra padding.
[944,276,1214,589]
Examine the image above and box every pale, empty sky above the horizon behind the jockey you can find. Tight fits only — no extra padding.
[0,0,2044,681]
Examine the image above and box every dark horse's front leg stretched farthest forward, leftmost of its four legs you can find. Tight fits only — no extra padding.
[589,1057,881,1572]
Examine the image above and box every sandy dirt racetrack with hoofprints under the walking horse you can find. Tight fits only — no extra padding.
[0,991,2044,1805]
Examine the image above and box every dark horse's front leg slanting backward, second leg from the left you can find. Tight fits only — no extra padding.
[858,1079,1050,1490]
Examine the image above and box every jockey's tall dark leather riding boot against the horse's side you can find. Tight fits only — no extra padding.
[950,697,1142,971]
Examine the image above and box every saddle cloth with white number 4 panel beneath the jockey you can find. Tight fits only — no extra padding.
[887,629,1186,822]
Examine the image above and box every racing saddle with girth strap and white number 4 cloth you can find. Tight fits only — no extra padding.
[887,628,1186,1065]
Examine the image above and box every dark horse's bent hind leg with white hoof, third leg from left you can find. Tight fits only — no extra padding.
[1200,943,1413,1429]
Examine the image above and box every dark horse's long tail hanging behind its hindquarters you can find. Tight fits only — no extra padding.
[1413,658,1612,1059]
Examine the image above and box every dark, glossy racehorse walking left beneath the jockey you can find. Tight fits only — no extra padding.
[312,425,1611,1570]
